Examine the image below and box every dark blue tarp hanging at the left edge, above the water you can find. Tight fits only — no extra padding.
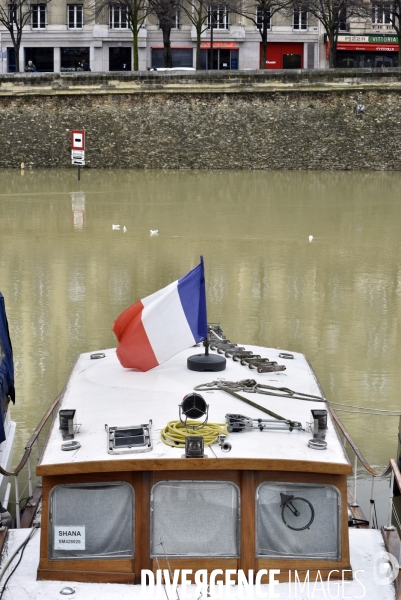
[0,292,15,443]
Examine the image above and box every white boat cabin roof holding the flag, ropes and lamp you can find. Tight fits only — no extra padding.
[40,346,349,470]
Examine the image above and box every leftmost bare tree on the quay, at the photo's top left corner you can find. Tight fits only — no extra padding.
[0,0,50,73]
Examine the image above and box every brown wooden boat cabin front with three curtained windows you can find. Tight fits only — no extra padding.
[38,470,352,583]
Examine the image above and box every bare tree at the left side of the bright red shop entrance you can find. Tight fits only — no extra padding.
[234,0,293,69]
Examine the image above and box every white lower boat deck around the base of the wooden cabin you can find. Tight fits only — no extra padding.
[1,529,395,600]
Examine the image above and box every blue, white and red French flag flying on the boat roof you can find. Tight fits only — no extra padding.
[113,257,207,371]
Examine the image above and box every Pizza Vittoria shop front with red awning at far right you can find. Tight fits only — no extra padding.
[326,35,398,69]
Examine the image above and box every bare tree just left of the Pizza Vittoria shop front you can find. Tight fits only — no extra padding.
[294,0,371,68]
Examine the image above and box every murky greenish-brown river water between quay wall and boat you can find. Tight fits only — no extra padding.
[0,169,401,520]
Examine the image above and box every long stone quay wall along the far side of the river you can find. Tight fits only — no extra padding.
[0,69,401,170]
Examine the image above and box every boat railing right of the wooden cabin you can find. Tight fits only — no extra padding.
[328,404,401,531]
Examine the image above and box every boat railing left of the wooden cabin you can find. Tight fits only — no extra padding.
[0,390,64,529]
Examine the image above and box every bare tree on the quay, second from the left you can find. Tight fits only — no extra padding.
[91,0,149,71]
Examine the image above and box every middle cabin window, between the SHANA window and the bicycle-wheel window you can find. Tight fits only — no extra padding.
[151,481,240,557]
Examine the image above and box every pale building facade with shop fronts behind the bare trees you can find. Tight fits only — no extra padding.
[0,0,398,73]
